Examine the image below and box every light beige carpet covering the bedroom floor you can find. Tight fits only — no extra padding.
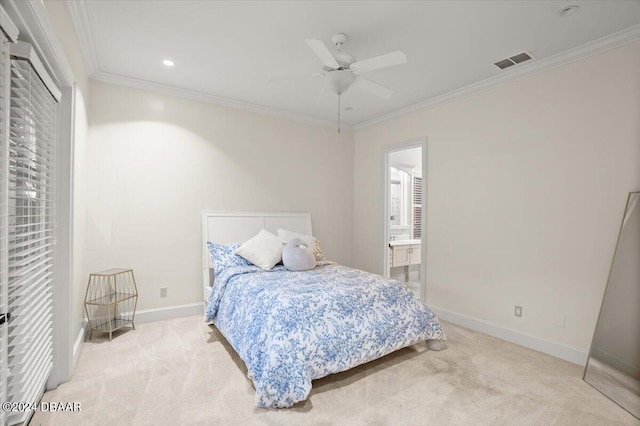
[31,316,640,426]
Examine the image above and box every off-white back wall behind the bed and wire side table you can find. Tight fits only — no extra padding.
[85,81,353,310]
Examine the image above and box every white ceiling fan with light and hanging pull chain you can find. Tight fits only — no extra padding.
[274,33,407,133]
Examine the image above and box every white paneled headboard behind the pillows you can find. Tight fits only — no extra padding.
[202,211,313,286]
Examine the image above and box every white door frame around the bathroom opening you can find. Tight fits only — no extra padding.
[380,136,429,302]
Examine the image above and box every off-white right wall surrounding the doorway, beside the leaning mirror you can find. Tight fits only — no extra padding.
[353,42,640,353]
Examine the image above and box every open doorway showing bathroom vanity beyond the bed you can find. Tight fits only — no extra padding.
[383,139,427,301]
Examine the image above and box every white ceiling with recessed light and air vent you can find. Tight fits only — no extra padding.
[68,0,640,126]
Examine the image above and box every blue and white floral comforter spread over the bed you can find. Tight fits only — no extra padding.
[206,263,446,407]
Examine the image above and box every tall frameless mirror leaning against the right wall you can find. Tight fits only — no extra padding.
[584,192,640,419]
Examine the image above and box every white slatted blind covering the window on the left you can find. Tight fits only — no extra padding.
[7,59,56,424]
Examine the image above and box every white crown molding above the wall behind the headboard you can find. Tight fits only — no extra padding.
[91,71,353,132]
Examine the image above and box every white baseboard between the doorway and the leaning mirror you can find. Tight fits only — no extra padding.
[429,305,589,367]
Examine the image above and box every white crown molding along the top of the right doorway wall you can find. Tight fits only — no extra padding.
[354,25,640,132]
